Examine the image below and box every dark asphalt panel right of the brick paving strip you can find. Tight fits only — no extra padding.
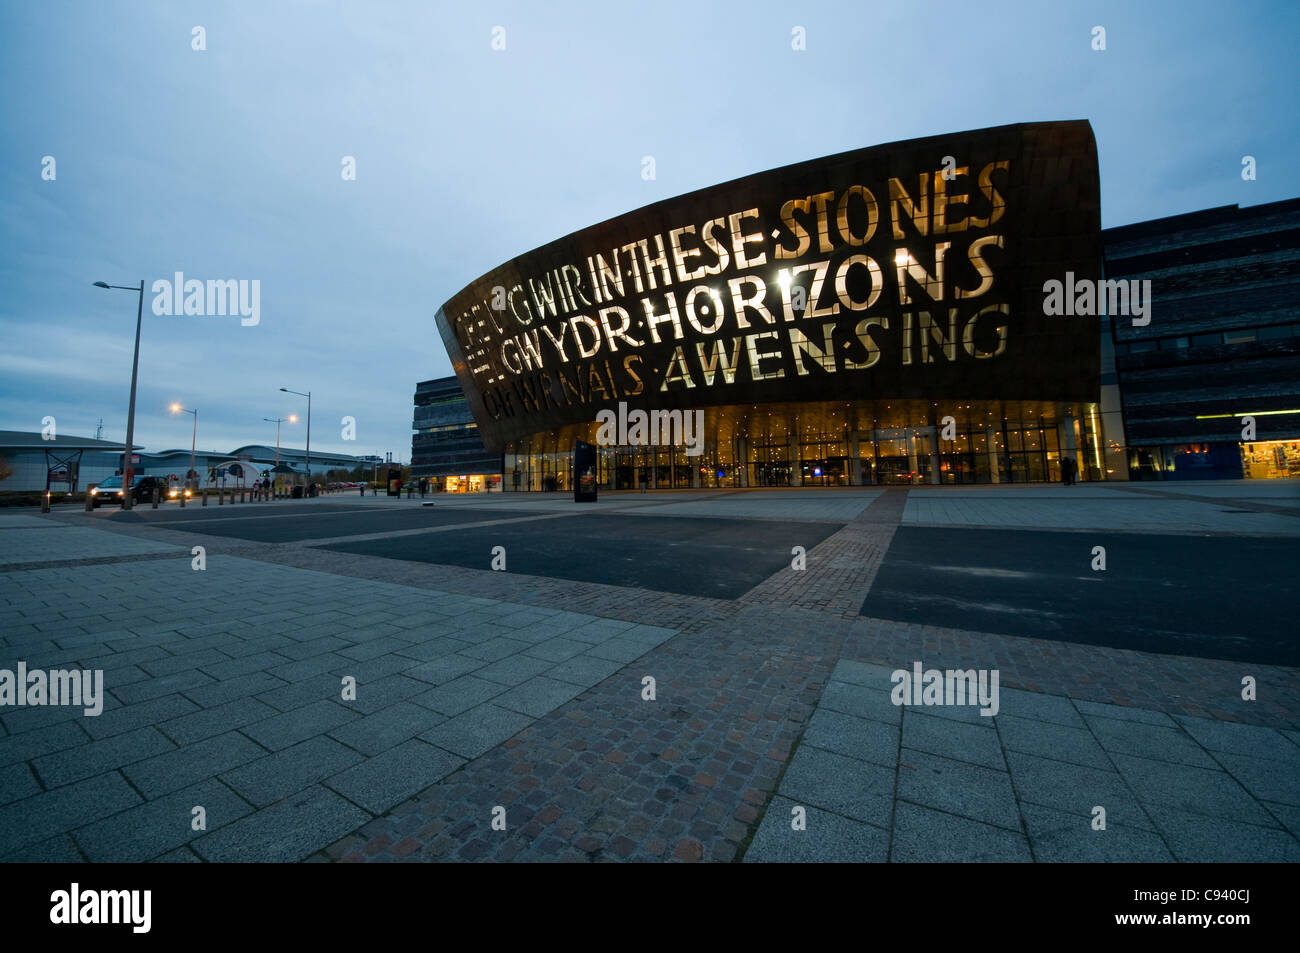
[862,527,1300,666]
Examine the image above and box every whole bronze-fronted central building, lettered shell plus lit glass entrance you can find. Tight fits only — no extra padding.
[437,121,1101,490]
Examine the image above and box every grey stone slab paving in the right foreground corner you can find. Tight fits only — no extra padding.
[745,660,1300,862]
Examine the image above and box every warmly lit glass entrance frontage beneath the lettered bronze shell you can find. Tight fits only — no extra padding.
[504,400,1104,491]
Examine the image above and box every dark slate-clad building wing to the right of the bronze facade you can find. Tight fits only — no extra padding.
[1102,199,1300,480]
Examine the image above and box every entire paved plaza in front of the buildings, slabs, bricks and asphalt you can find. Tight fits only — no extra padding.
[0,481,1300,862]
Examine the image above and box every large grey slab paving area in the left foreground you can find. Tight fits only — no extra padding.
[0,553,675,861]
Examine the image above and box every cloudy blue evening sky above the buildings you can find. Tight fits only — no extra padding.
[0,0,1300,460]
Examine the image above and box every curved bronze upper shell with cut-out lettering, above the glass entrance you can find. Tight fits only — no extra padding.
[437,122,1100,447]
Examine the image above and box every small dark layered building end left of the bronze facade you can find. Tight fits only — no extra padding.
[411,377,502,493]
